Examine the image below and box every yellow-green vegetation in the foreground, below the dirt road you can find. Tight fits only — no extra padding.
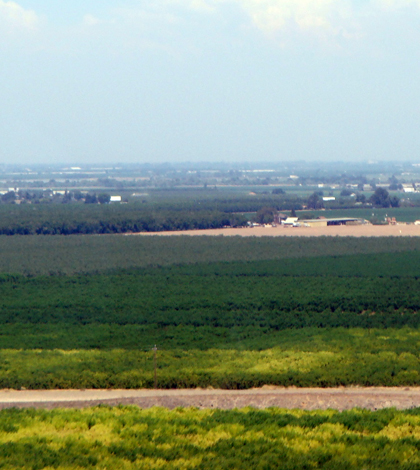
[0,407,420,470]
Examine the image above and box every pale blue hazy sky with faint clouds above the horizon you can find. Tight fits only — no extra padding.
[0,0,420,163]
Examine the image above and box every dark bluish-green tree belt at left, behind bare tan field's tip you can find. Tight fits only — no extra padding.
[0,204,246,235]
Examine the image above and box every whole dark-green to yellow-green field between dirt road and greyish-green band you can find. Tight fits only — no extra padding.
[0,250,420,388]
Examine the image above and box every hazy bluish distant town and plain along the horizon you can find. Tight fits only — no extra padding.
[0,162,420,209]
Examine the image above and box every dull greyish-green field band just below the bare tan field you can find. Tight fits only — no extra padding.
[0,235,420,275]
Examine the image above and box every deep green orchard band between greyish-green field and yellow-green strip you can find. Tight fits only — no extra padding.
[0,252,420,330]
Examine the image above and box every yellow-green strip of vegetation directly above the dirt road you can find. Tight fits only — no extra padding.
[0,328,420,389]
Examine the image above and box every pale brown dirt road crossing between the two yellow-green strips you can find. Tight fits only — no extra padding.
[0,386,420,410]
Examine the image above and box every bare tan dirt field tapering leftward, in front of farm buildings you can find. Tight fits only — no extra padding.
[130,224,420,237]
